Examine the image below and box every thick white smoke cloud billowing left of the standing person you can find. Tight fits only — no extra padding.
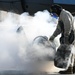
[0,10,67,72]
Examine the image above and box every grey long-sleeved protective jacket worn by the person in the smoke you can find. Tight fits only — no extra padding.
[50,9,74,44]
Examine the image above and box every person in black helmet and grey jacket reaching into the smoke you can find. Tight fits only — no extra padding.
[49,4,75,74]
